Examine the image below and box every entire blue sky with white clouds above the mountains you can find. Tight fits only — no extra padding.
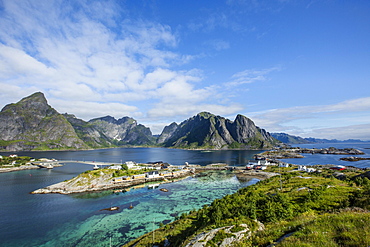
[0,0,370,140]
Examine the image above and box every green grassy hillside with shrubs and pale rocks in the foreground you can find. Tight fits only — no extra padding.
[124,167,370,247]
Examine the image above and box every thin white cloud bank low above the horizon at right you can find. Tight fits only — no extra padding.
[248,97,370,139]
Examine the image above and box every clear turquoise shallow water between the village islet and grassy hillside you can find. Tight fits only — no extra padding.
[37,173,258,246]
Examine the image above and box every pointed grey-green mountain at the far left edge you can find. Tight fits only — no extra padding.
[0,92,88,151]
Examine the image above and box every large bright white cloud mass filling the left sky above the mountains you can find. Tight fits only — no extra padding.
[0,0,247,128]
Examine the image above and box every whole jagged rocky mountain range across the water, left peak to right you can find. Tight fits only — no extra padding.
[0,92,280,151]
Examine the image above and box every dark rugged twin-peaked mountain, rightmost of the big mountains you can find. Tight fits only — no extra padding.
[161,112,278,149]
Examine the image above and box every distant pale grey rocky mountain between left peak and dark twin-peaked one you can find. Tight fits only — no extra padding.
[89,116,155,145]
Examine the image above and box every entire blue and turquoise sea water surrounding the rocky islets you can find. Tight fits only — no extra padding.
[0,143,370,247]
